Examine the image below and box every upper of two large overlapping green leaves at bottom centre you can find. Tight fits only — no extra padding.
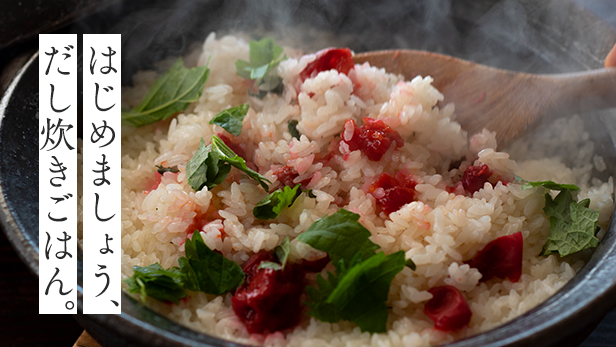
[298,209,379,265]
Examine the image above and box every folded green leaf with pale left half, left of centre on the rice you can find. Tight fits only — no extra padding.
[186,138,231,192]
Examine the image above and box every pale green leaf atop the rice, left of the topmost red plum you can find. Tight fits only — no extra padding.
[235,37,286,91]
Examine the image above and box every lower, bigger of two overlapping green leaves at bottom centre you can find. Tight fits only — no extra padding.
[308,251,405,332]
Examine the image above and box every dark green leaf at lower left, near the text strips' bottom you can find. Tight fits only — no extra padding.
[124,263,186,304]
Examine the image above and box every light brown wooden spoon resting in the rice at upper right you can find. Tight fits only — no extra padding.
[353,50,616,147]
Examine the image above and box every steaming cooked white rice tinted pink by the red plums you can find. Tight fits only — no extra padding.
[114,34,614,347]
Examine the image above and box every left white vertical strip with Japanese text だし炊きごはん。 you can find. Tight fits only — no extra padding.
[38,34,78,314]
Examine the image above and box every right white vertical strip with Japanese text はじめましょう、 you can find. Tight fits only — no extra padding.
[83,34,122,314]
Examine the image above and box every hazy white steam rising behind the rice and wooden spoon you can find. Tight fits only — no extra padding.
[70,0,613,178]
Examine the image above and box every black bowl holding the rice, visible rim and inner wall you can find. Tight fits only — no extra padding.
[0,0,616,347]
